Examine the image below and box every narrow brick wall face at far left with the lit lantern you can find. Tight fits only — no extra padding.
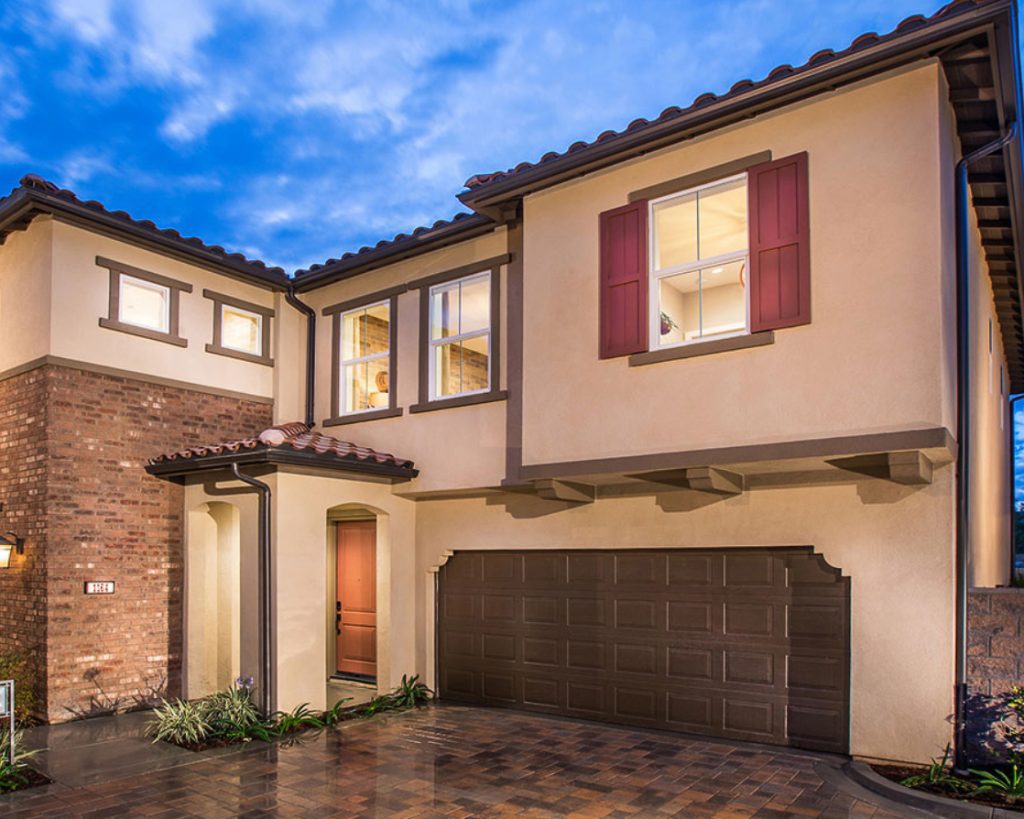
[0,370,46,708]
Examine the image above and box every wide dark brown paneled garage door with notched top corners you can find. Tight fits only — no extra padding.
[437,548,850,752]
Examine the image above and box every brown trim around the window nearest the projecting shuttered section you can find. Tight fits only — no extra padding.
[409,253,512,413]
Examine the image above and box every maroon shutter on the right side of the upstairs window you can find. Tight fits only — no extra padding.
[748,152,811,333]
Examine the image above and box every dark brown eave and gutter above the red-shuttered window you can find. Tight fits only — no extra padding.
[459,0,1013,212]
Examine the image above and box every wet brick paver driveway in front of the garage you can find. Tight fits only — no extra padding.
[0,706,910,817]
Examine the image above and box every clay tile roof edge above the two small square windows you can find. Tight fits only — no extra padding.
[0,173,287,283]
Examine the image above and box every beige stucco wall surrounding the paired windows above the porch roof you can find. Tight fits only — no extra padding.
[303,228,508,492]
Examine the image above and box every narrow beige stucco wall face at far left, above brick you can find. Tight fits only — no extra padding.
[0,217,53,373]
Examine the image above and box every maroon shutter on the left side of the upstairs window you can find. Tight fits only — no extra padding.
[601,200,647,358]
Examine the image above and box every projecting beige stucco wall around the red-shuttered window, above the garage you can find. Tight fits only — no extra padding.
[523,62,949,464]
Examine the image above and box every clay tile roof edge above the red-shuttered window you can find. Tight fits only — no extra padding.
[461,0,993,193]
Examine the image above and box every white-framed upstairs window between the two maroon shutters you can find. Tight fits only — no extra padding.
[648,174,750,350]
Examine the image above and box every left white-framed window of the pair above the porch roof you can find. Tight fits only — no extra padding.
[338,300,392,416]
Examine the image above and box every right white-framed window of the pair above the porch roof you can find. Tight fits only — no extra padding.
[428,270,492,400]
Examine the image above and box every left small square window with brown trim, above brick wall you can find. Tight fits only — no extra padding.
[96,256,193,347]
